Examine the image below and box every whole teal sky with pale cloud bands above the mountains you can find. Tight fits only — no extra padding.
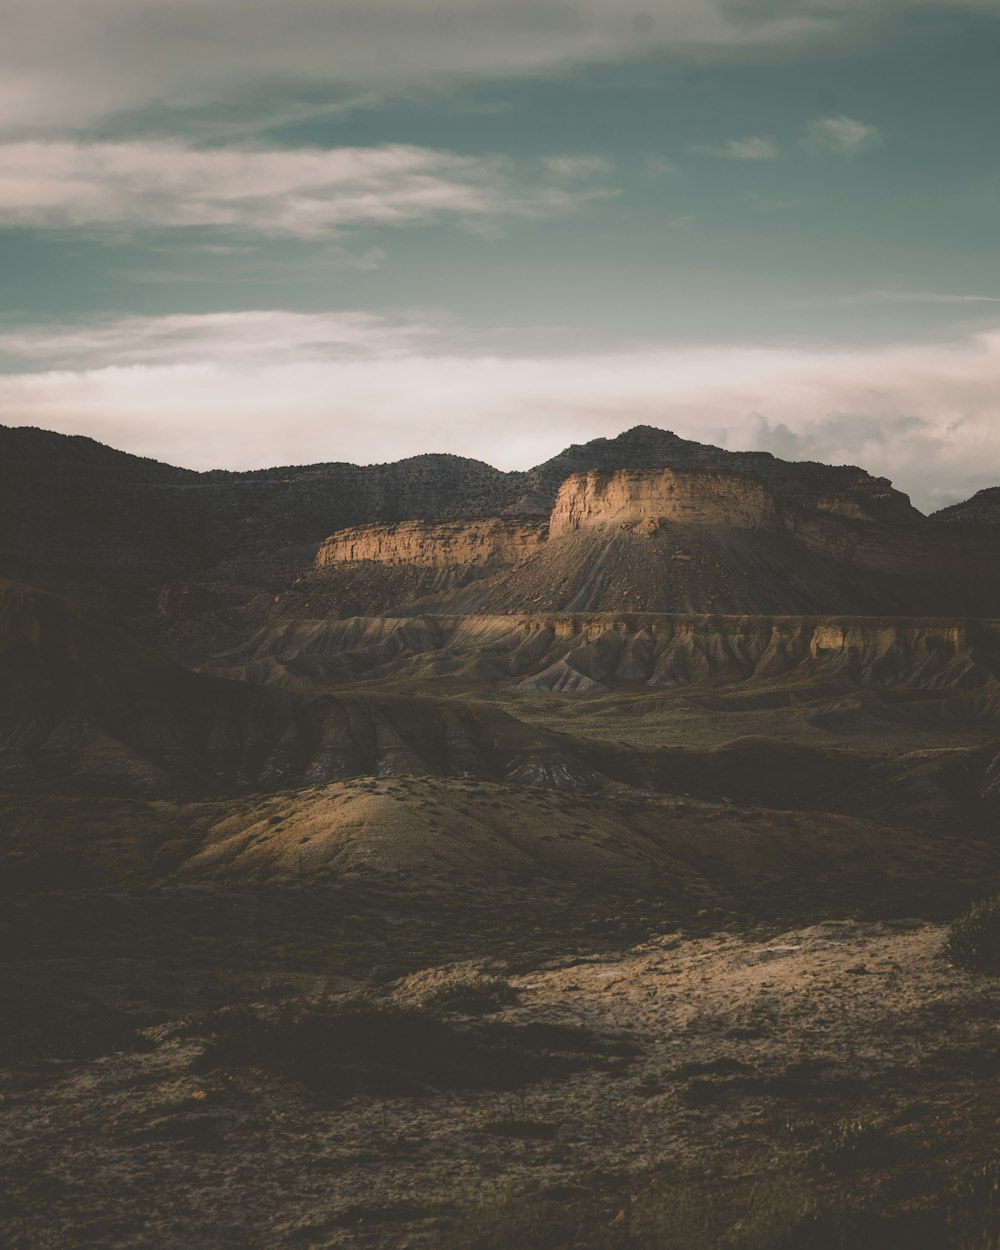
[0,0,1000,511]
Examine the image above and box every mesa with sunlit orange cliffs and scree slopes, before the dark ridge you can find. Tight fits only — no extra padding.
[302,461,1000,616]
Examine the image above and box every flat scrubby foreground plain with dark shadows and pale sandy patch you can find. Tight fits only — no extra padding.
[1,883,1000,1250]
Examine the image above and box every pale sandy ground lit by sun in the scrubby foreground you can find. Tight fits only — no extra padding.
[0,921,1000,1250]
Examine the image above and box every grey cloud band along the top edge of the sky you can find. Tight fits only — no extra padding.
[0,0,995,133]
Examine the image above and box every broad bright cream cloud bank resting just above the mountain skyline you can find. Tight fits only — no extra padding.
[0,311,1000,510]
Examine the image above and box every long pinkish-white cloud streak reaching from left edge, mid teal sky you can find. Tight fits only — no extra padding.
[0,141,610,239]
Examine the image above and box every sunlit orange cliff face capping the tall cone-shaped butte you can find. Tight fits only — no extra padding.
[550,469,780,538]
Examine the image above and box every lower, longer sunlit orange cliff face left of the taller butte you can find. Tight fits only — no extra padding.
[316,518,548,569]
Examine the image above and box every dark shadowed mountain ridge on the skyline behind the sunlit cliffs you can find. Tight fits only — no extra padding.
[0,426,919,614]
